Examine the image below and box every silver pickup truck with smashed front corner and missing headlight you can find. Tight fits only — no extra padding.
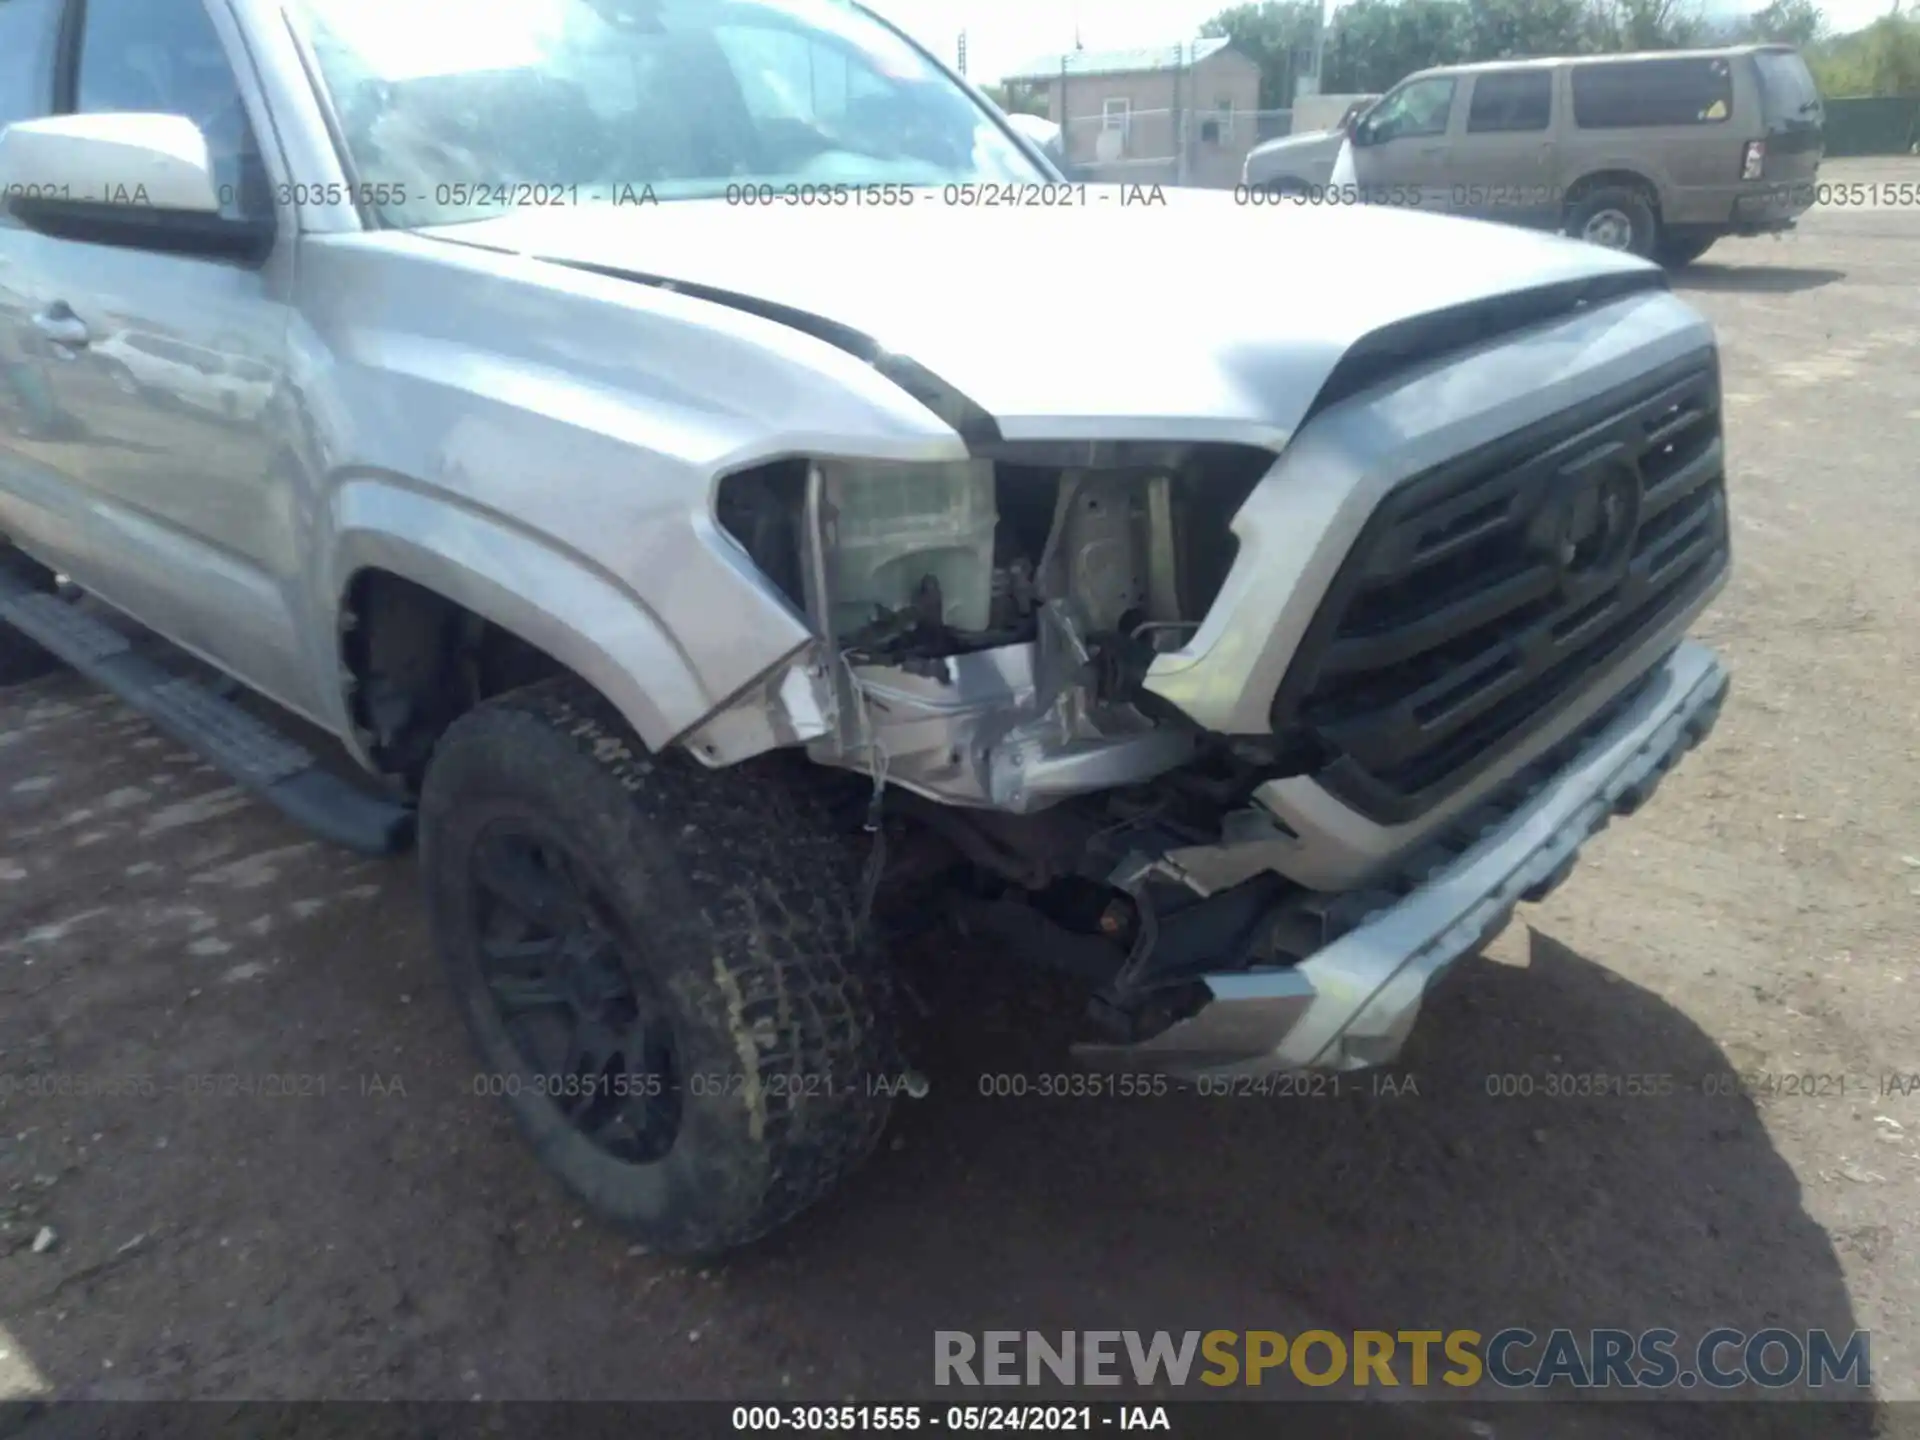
[0,0,1728,1252]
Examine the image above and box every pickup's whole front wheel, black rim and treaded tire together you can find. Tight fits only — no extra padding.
[420,680,893,1252]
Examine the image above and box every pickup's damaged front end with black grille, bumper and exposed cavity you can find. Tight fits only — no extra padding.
[689,312,1730,1075]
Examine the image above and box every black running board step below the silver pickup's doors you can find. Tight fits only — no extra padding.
[0,564,413,854]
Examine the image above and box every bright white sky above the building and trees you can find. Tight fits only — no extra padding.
[868,0,1891,83]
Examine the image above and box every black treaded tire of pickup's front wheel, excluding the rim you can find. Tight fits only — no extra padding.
[420,680,899,1254]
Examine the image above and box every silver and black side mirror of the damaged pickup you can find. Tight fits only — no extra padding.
[0,113,273,257]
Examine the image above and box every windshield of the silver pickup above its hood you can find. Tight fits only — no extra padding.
[298,0,1046,227]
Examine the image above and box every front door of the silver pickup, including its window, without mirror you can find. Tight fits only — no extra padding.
[0,0,313,708]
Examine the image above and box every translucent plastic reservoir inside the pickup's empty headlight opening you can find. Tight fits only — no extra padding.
[822,461,996,636]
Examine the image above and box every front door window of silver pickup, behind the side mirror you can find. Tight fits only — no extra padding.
[71,0,271,219]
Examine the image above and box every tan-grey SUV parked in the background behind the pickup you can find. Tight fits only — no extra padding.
[1242,44,1824,265]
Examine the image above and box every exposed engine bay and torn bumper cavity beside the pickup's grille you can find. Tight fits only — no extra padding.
[718,445,1325,1039]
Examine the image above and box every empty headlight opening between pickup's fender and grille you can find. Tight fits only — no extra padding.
[716,445,1271,675]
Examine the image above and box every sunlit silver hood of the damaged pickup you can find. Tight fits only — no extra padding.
[424,186,1665,449]
